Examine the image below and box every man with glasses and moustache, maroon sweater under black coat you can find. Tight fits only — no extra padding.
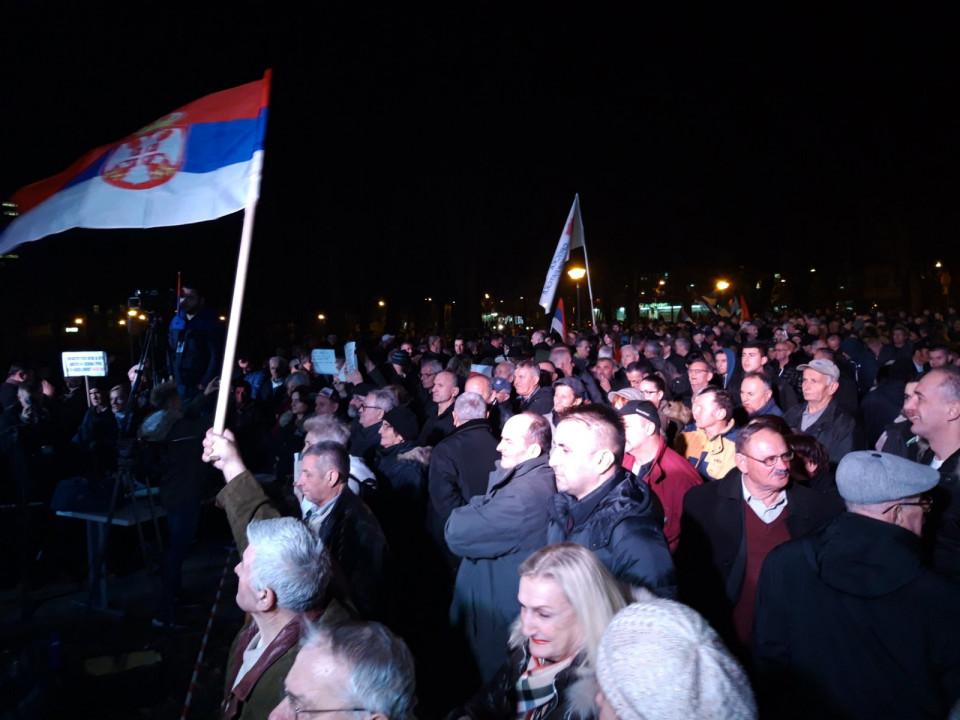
[676,422,842,656]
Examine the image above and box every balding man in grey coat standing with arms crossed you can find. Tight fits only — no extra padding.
[445,413,557,682]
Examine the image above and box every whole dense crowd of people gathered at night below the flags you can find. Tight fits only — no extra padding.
[0,298,960,720]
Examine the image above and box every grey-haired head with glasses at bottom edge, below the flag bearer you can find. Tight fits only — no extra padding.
[270,622,416,720]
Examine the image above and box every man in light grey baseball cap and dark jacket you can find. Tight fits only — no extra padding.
[783,360,858,463]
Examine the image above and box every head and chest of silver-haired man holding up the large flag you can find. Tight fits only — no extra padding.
[222,518,347,720]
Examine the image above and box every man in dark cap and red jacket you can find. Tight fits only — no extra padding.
[617,400,703,553]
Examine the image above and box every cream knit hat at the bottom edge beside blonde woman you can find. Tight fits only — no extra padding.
[597,596,757,720]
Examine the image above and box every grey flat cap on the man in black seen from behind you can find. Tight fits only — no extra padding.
[837,450,940,505]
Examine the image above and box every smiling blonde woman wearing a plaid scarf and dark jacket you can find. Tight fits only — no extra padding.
[450,543,628,720]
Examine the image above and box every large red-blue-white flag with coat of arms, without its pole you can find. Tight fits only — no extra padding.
[0,71,270,254]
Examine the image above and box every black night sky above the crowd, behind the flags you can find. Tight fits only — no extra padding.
[0,2,960,346]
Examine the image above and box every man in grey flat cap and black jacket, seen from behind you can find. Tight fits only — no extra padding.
[755,452,960,718]
